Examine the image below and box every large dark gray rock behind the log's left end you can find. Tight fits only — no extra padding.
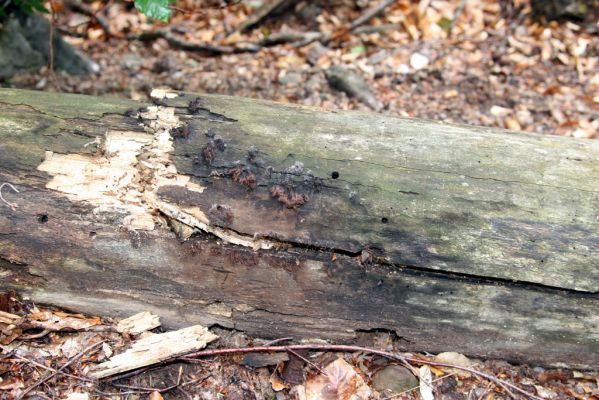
[0,11,99,79]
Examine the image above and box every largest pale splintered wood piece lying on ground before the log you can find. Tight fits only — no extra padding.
[90,325,218,379]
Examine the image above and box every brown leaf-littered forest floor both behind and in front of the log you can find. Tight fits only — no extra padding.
[0,0,599,400]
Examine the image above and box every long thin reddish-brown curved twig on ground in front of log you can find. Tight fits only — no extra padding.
[178,344,543,400]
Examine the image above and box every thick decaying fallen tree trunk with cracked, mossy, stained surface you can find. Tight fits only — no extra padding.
[0,89,599,367]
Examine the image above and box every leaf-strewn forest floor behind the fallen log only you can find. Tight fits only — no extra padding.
[8,0,599,138]
